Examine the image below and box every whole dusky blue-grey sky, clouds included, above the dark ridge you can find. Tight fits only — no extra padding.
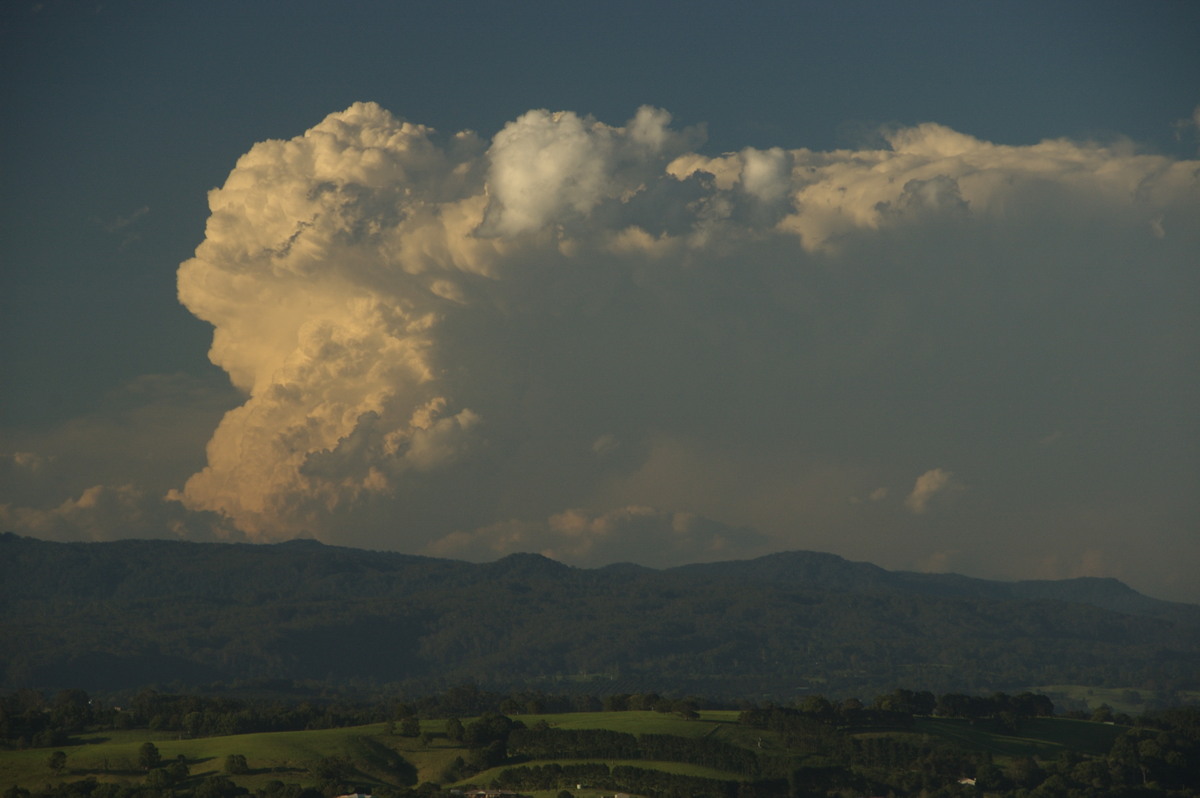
[0,1,1200,601]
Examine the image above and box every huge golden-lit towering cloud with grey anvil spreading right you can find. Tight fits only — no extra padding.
[159,103,1200,585]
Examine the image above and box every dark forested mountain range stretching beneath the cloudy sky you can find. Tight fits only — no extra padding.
[0,534,1200,697]
